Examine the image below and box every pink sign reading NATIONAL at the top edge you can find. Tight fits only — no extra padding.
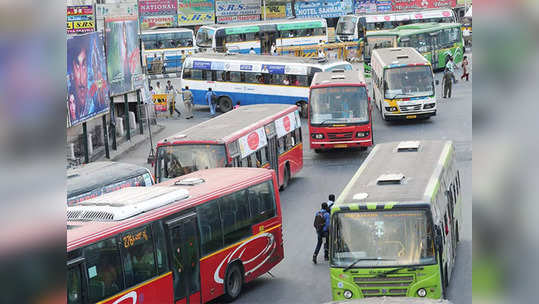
[138,0,178,30]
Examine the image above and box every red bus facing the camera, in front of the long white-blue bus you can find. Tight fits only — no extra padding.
[308,70,373,152]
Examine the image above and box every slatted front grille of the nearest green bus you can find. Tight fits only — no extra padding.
[354,275,414,297]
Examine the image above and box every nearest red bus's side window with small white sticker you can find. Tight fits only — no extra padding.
[83,237,125,303]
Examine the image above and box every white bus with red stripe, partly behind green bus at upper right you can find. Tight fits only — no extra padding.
[335,8,456,41]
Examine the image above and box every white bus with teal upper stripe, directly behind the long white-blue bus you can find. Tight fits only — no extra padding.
[196,18,328,54]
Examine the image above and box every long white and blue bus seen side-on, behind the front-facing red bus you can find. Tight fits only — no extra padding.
[182,53,352,115]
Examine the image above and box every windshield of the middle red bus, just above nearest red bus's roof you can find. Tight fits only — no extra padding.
[157,144,226,182]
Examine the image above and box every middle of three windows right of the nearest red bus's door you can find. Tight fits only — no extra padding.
[219,190,252,246]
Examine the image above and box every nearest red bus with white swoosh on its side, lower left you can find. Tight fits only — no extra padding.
[67,168,284,304]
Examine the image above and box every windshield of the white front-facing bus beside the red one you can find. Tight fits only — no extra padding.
[384,65,434,99]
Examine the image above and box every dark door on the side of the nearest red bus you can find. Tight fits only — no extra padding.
[166,212,201,304]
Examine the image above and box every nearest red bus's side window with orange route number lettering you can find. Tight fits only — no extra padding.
[121,226,157,287]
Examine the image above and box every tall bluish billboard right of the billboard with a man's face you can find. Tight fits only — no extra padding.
[105,17,144,95]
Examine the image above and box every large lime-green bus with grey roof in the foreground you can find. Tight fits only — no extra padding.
[329,141,462,300]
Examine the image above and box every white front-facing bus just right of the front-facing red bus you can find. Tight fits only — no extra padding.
[371,47,436,120]
